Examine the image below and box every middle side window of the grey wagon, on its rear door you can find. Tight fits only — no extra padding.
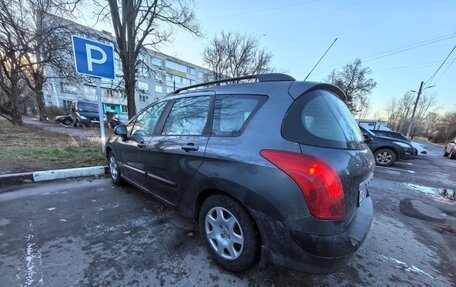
[162,96,211,135]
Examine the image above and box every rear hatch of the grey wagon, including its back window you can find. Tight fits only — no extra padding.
[282,89,375,225]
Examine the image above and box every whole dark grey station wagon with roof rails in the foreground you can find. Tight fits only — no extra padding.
[106,74,375,273]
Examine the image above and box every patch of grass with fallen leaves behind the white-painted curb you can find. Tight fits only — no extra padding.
[0,119,106,174]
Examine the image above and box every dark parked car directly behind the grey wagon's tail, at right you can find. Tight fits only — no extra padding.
[359,126,415,166]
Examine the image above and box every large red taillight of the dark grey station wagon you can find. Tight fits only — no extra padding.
[260,150,345,220]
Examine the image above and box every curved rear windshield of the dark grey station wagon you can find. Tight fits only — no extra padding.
[282,90,366,149]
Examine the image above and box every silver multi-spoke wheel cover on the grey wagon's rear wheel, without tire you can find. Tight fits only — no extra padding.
[205,207,244,260]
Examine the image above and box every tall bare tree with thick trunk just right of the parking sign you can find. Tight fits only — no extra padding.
[96,0,199,118]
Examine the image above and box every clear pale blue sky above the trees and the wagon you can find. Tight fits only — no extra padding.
[79,0,456,117]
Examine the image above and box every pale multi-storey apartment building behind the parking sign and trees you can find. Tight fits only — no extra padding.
[44,16,211,114]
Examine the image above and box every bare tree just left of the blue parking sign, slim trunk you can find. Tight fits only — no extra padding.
[0,0,80,120]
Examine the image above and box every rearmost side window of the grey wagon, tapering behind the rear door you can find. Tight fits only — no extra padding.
[212,95,267,136]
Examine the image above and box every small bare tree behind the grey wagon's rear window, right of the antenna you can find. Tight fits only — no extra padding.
[326,59,377,115]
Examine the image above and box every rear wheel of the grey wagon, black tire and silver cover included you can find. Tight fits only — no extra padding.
[198,194,261,272]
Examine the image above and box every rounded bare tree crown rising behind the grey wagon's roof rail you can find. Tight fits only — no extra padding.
[203,32,272,80]
